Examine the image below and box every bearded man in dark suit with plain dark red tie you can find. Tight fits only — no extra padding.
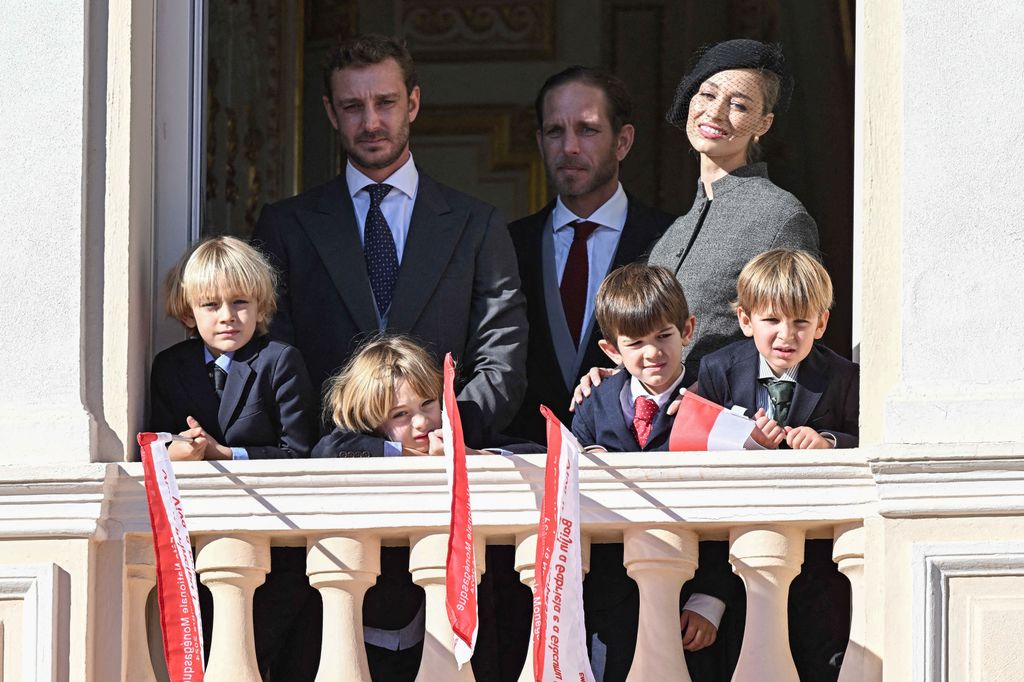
[509,67,673,442]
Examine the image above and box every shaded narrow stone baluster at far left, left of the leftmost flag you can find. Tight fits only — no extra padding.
[123,536,157,682]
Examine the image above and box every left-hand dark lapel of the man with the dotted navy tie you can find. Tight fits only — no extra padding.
[299,175,378,332]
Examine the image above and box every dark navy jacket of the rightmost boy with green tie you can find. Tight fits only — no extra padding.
[697,339,860,447]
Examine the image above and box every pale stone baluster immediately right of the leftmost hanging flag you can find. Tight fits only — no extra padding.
[196,534,270,682]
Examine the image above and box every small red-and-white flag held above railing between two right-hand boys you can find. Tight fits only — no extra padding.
[669,391,764,452]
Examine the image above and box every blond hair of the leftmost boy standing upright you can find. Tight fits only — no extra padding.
[165,237,278,334]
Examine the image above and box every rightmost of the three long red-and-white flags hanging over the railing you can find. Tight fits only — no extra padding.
[534,406,594,682]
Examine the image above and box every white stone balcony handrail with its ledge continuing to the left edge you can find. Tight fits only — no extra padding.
[0,451,877,543]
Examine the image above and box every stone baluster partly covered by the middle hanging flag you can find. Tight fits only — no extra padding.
[409,531,485,682]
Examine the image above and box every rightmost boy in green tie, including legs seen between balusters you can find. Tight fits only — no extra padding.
[690,249,859,680]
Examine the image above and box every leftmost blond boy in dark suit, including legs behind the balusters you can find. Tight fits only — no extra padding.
[148,237,319,680]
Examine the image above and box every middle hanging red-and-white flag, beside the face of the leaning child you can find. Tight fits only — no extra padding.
[441,353,477,670]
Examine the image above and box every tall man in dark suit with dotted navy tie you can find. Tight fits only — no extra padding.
[253,35,526,429]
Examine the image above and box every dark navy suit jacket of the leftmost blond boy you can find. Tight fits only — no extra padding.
[150,336,318,459]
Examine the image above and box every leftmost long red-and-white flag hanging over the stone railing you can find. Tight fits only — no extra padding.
[138,433,203,682]
